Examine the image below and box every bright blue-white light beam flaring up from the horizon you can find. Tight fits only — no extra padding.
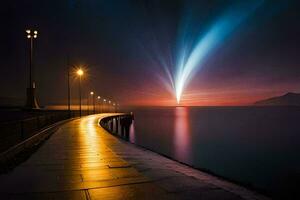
[174,1,262,104]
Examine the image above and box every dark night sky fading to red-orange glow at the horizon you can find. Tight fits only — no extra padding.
[0,0,300,105]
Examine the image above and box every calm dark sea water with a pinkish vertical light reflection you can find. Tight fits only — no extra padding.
[125,107,300,197]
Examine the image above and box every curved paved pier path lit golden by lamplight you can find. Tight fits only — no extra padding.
[0,114,267,200]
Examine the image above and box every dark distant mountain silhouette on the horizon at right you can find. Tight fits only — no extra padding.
[254,92,300,106]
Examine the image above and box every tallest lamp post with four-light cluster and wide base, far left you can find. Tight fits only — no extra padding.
[26,29,39,109]
